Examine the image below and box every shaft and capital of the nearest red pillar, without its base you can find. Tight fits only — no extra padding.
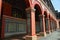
[26,8,35,35]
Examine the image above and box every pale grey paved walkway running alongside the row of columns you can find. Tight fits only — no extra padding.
[38,30,60,40]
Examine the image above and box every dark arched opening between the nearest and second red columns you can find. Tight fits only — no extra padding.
[34,4,42,33]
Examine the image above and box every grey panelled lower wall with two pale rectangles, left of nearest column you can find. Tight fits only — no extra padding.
[5,20,26,33]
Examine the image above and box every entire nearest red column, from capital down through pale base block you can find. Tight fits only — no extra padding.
[26,7,37,40]
